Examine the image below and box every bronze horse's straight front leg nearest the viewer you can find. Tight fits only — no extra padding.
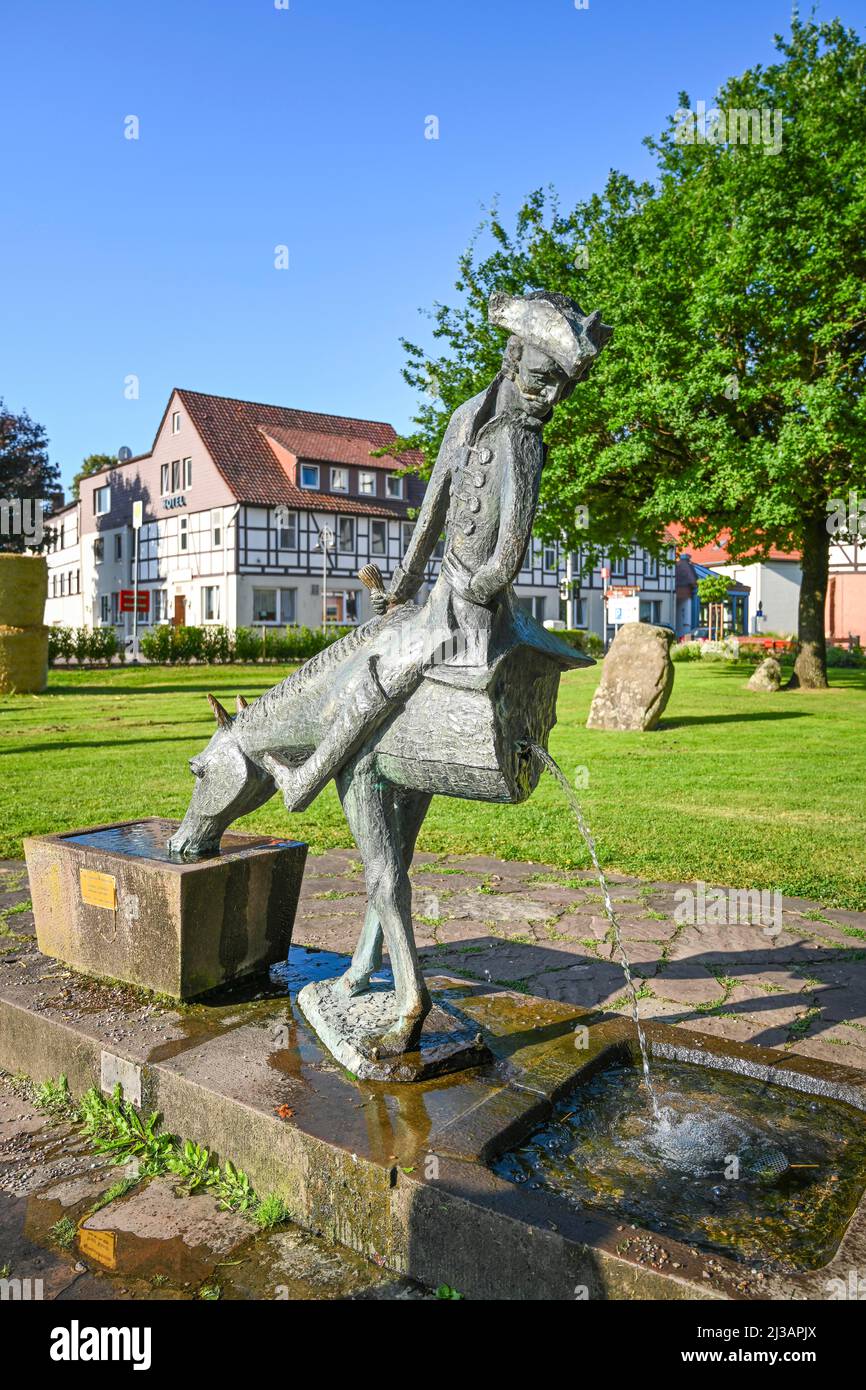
[338,755,431,1055]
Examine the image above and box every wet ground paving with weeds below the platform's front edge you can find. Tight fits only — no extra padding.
[0,1076,432,1301]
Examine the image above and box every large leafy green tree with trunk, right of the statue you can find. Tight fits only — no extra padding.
[396,21,866,687]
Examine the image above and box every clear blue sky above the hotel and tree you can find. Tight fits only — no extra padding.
[0,0,865,484]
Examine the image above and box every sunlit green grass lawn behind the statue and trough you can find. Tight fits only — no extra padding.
[0,663,866,909]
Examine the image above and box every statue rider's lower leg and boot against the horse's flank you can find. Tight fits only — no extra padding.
[261,662,400,810]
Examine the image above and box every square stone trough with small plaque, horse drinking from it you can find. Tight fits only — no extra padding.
[24,817,307,999]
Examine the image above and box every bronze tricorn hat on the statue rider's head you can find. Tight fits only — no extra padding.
[487,289,613,379]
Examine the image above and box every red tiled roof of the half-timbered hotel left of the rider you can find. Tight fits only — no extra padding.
[178,388,421,516]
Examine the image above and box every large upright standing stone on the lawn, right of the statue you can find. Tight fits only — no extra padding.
[587,623,674,733]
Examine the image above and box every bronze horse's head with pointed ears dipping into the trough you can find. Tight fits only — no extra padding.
[168,695,277,859]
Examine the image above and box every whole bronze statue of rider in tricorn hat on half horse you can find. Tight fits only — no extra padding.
[170,292,612,1079]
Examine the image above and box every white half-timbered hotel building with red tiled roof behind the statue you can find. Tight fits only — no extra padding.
[46,389,676,641]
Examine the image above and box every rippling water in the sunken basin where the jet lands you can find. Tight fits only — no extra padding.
[492,1063,866,1270]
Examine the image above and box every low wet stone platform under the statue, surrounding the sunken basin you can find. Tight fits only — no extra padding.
[0,922,866,1300]
